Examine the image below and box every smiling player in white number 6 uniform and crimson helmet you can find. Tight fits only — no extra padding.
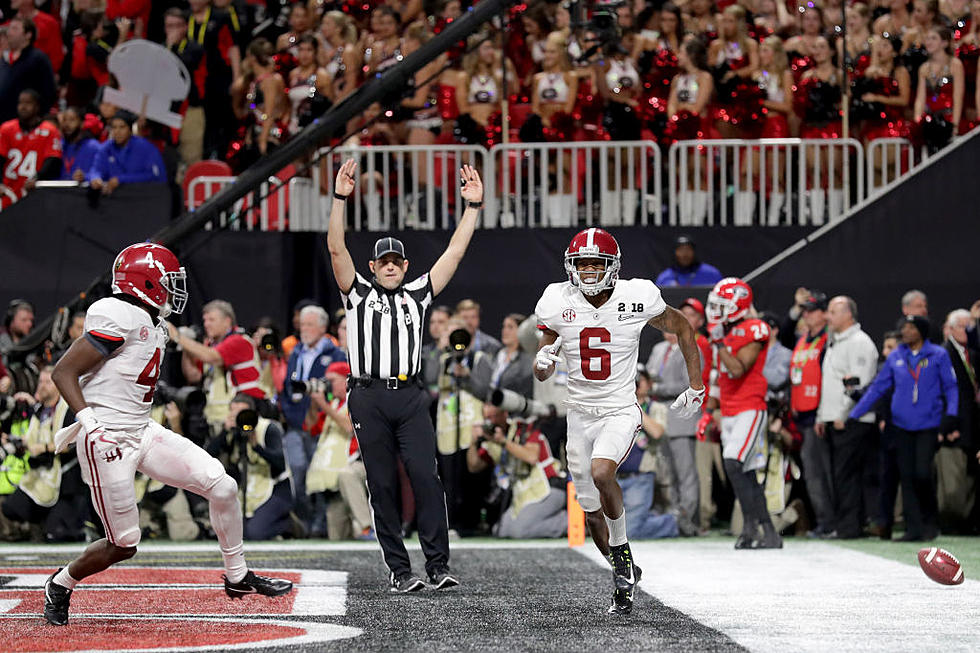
[534,228,705,614]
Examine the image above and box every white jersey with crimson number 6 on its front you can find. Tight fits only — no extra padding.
[534,279,667,408]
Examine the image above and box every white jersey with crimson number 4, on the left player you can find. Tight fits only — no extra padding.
[80,297,167,430]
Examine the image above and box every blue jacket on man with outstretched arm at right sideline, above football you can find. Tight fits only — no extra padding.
[850,342,959,431]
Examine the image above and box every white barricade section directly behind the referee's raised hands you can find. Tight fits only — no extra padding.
[313,145,496,231]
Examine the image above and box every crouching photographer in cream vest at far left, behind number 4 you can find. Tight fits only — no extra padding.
[0,367,89,542]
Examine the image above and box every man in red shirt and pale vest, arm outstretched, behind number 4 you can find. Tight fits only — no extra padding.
[167,299,268,419]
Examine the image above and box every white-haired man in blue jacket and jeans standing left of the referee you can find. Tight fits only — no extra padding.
[279,305,347,529]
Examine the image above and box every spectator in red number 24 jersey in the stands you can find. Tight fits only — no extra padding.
[0,89,61,199]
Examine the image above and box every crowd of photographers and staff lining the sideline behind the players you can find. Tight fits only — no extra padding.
[0,276,980,542]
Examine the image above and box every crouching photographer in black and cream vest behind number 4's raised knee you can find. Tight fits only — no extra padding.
[207,393,293,540]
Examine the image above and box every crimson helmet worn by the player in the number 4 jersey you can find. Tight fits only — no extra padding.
[112,243,187,317]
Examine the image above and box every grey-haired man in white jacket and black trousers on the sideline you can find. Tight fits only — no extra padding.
[815,295,878,539]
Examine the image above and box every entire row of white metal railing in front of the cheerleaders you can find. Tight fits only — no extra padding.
[180,138,932,231]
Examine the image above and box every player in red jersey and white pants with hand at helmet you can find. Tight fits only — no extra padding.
[706,277,783,549]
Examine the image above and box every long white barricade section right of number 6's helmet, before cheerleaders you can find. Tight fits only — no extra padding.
[668,138,865,226]
